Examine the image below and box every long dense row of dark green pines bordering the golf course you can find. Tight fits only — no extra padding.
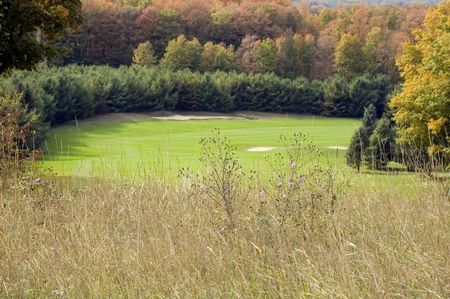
[0,65,391,146]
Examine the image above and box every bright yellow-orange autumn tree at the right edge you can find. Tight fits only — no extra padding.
[390,0,450,159]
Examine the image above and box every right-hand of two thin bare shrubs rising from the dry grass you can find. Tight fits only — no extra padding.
[261,133,339,234]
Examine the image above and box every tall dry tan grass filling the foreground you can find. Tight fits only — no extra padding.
[0,169,450,298]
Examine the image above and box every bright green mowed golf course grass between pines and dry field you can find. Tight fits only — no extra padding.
[40,114,360,176]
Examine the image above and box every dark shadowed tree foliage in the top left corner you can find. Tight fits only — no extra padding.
[0,0,81,73]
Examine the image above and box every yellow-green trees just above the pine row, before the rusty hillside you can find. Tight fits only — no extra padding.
[132,32,386,80]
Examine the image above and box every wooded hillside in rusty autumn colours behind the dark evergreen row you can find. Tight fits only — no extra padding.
[60,0,428,81]
